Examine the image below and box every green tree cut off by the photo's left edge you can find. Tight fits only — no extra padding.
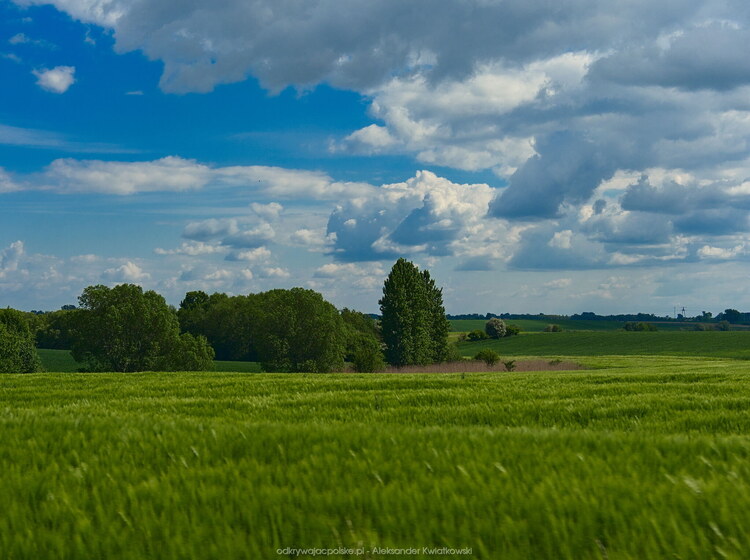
[0,309,41,373]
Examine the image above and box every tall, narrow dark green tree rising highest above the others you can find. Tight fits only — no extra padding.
[378,258,450,367]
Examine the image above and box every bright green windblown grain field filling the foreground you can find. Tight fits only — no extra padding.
[0,352,750,560]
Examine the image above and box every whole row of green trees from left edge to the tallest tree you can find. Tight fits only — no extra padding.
[0,259,452,372]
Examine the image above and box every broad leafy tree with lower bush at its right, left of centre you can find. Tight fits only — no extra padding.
[72,284,214,372]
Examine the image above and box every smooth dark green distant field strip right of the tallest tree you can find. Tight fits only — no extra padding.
[459,331,750,359]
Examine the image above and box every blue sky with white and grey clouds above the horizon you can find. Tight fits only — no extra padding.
[0,0,750,315]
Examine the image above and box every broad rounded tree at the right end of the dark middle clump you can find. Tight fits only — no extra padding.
[253,288,346,372]
